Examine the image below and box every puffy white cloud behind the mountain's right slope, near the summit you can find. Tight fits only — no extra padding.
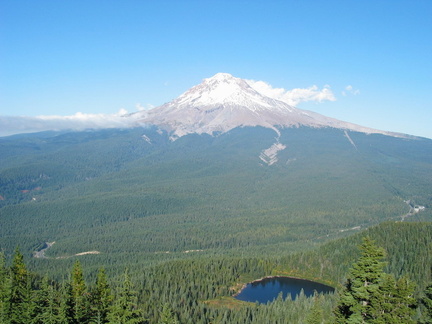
[246,80,336,106]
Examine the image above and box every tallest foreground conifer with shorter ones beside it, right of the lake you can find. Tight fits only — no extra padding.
[335,237,416,324]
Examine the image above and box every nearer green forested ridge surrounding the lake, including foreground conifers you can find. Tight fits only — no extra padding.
[0,222,432,323]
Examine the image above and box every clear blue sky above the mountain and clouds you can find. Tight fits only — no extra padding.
[0,0,432,138]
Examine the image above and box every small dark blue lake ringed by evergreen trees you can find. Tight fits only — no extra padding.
[235,277,334,304]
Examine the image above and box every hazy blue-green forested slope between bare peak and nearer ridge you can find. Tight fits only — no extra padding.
[0,127,432,270]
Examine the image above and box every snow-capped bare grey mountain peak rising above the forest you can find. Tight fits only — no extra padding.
[134,73,402,139]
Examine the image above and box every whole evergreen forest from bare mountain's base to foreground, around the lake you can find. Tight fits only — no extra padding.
[0,128,432,323]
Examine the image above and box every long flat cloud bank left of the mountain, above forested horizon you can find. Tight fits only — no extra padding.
[0,109,138,136]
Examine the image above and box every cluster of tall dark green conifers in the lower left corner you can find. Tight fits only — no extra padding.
[0,249,145,324]
